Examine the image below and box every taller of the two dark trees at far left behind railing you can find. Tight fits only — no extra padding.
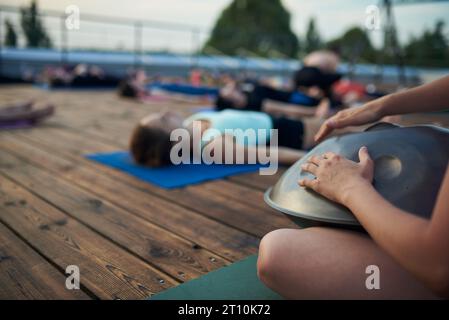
[20,0,51,48]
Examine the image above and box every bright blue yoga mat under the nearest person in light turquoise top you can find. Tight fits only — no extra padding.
[86,151,262,189]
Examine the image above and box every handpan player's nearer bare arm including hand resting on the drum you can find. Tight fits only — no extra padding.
[300,148,449,297]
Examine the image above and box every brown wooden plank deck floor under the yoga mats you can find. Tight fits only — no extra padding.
[0,86,446,299]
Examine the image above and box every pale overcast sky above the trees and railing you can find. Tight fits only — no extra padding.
[0,0,449,49]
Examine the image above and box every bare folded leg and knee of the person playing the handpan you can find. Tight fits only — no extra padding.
[258,228,436,299]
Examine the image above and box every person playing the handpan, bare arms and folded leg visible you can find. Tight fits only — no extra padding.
[258,76,449,299]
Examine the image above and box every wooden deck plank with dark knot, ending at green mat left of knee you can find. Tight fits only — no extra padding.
[0,149,228,281]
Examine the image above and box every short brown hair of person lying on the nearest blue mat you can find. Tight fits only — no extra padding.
[130,124,172,167]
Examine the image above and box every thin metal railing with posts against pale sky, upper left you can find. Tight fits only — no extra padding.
[0,6,210,64]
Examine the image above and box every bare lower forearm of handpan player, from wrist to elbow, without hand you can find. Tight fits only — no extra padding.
[345,171,449,298]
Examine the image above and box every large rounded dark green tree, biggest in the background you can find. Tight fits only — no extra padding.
[203,0,299,58]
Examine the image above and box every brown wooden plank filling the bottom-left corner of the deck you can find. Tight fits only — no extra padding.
[0,223,90,300]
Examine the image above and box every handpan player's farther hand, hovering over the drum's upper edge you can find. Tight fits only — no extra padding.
[315,99,382,142]
